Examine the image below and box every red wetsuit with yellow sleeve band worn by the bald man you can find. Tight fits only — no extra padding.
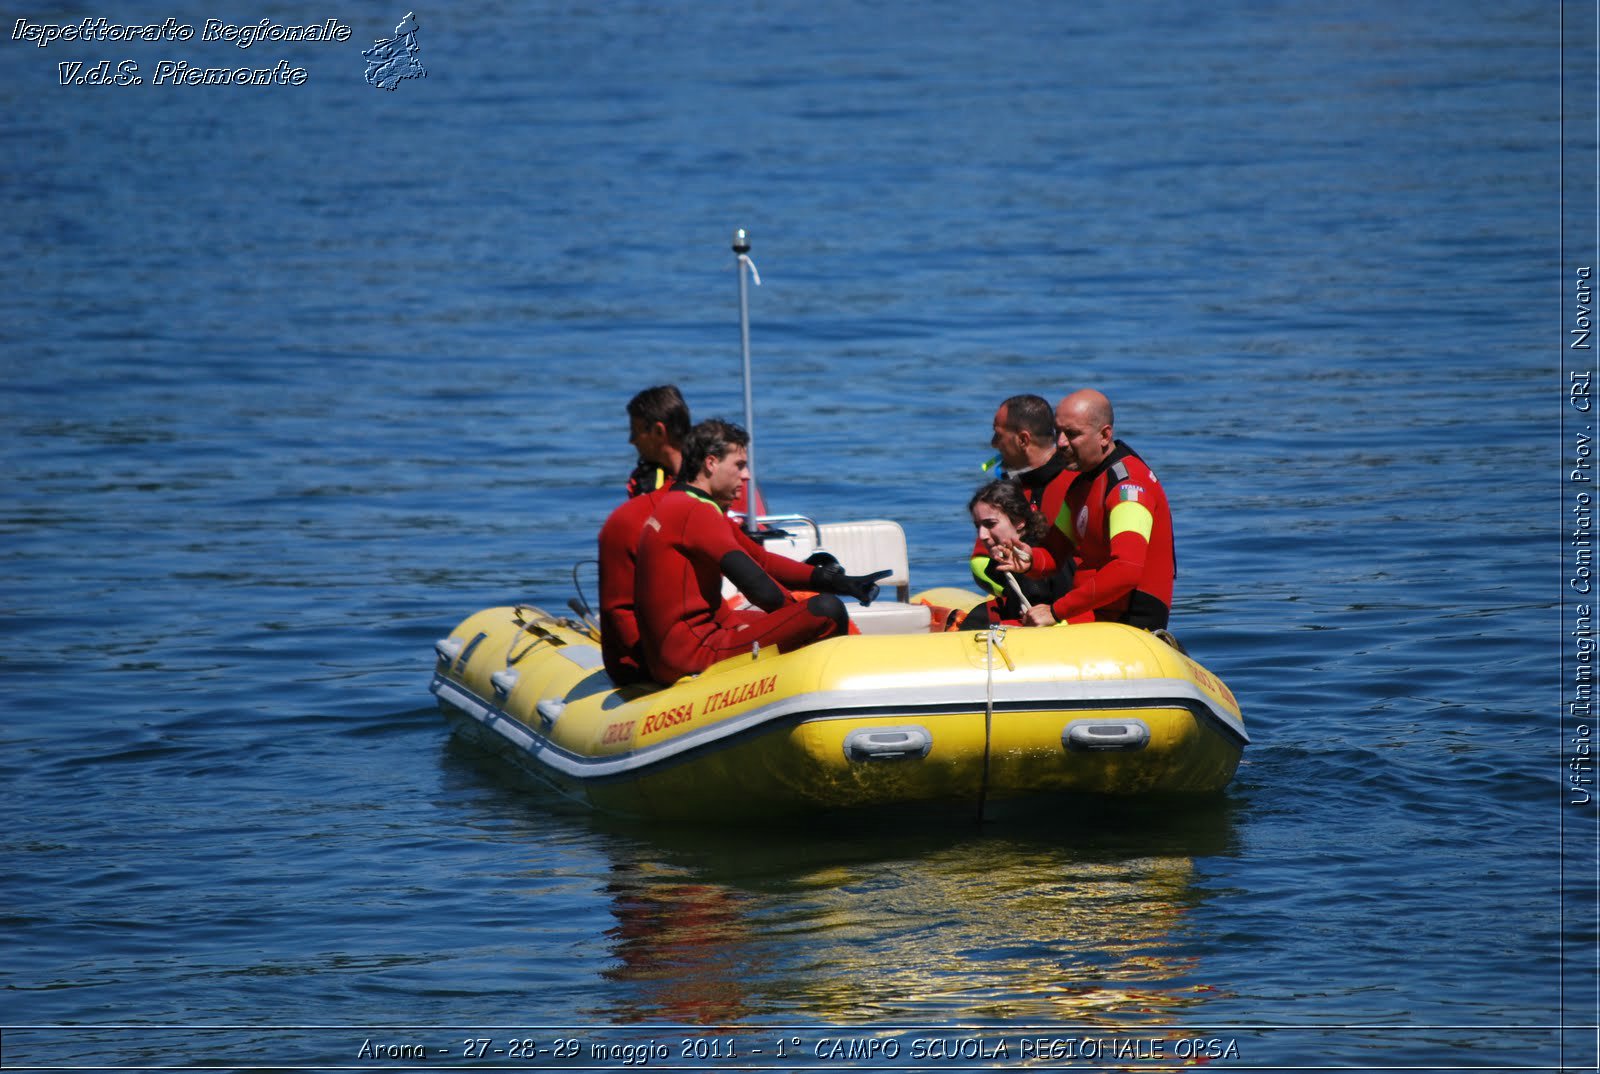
[1030,440,1176,631]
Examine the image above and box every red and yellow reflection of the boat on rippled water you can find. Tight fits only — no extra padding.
[594,802,1232,1028]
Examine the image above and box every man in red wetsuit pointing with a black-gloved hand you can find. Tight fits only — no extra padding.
[634,419,890,685]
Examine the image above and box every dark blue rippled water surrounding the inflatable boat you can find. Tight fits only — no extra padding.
[0,0,1595,1069]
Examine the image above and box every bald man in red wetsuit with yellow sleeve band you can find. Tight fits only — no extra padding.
[997,389,1176,631]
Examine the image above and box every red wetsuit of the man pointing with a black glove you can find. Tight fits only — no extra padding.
[634,488,842,685]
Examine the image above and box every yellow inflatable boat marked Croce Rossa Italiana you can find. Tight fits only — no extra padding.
[432,523,1250,821]
